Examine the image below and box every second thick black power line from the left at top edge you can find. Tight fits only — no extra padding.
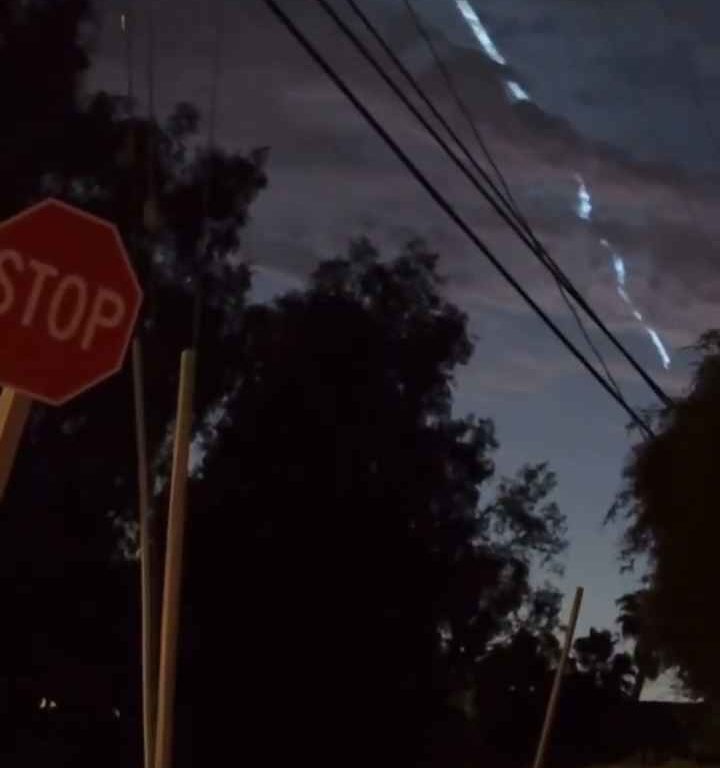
[317,0,672,406]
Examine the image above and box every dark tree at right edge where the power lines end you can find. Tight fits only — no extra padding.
[612,331,720,701]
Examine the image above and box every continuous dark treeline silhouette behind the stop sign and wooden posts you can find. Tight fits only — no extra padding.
[0,0,716,768]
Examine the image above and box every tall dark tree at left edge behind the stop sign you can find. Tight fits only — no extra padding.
[0,0,265,765]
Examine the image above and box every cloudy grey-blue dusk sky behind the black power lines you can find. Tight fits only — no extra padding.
[88,0,720,695]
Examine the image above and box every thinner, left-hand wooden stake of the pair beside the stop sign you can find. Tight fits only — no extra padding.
[132,338,159,768]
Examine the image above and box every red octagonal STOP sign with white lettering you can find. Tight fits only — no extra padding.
[0,199,142,405]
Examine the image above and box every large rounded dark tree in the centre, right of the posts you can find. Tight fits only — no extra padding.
[178,240,564,765]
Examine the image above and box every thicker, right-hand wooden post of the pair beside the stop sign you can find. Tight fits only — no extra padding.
[154,349,195,768]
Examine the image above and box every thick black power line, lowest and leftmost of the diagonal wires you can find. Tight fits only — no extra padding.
[264,0,653,437]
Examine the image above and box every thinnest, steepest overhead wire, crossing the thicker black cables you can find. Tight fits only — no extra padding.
[388,0,622,393]
